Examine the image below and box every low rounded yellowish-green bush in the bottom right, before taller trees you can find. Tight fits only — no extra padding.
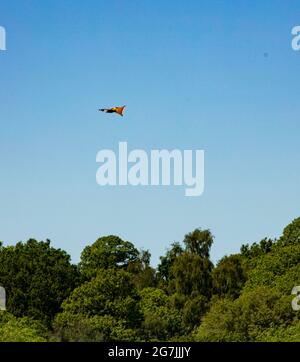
[195,287,294,342]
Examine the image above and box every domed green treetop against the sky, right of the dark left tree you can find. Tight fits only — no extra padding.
[79,235,139,279]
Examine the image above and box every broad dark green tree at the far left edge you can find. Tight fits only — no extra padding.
[0,239,79,322]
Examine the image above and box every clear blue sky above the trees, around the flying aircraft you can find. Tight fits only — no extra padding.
[0,0,300,264]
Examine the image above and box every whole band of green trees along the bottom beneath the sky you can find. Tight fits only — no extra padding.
[0,218,300,342]
